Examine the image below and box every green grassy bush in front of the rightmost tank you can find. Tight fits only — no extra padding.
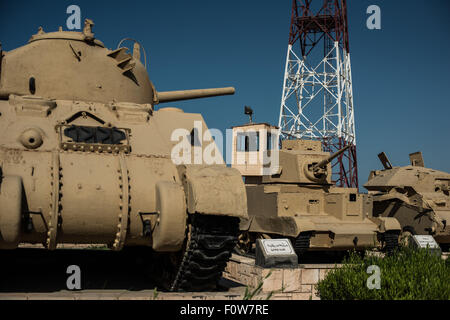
[316,248,450,300]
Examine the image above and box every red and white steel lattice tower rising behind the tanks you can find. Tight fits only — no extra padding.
[278,0,358,188]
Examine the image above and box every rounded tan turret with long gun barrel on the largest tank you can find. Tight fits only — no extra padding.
[0,19,234,105]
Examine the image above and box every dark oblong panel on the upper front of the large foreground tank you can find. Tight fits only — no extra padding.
[64,126,126,144]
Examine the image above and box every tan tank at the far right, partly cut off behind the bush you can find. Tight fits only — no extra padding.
[364,152,450,250]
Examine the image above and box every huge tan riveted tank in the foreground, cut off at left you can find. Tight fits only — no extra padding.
[0,20,247,290]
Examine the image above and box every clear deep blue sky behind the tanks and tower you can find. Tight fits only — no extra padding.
[0,0,450,184]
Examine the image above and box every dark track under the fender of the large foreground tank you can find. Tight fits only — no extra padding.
[170,215,239,291]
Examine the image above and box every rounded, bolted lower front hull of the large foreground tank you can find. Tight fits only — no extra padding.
[0,149,180,246]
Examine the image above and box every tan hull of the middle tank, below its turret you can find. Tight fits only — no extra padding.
[241,184,382,251]
